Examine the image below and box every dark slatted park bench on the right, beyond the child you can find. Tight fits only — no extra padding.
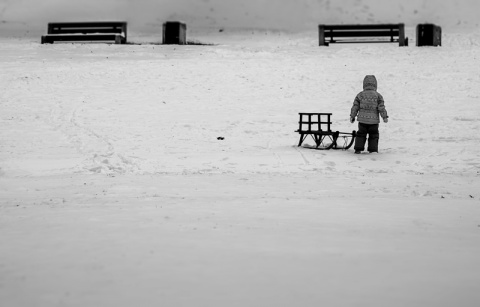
[318,23,408,46]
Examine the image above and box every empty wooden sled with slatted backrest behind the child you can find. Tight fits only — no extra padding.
[295,113,356,150]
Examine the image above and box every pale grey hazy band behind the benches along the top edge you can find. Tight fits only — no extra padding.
[0,0,480,30]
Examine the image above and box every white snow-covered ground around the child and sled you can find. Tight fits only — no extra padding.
[0,22,480,307]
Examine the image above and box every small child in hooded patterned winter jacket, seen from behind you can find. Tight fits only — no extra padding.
[350,75,388,154]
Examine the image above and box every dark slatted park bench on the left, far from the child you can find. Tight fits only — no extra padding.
[42,21,127,44]
